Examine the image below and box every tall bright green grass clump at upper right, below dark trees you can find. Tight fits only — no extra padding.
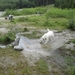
[46,8,75,19]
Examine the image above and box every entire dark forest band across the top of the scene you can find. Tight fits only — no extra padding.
[0,0,75,11]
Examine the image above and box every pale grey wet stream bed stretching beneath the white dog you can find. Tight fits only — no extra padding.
[13,30,75,65]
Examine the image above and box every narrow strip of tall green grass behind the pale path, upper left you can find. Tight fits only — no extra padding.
[4,7,47,16]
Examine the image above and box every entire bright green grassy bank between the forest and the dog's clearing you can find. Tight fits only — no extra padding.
[5,6,75,30]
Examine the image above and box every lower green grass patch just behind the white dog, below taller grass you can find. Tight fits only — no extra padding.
[25,15,68,30]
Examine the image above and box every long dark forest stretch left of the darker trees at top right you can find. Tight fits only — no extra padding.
[0,0,54,10]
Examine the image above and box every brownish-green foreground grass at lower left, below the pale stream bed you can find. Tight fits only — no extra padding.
[0,47,49,75]
